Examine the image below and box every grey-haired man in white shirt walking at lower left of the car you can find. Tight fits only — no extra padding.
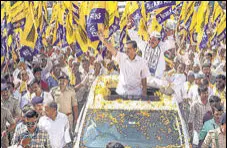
[38,102,71,148]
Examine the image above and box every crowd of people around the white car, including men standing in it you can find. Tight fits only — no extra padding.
[1,1,226,148]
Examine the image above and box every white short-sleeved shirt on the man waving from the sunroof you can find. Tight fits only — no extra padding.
[115,52,150,95]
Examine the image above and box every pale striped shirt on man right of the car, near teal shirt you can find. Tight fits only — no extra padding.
[188,98,211,133]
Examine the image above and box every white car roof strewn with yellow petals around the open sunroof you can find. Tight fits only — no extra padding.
[88,75,177,110]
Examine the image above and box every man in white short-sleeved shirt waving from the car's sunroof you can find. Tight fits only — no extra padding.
[99,32,150,96]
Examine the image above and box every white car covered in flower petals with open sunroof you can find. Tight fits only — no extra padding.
[74,76,189,148]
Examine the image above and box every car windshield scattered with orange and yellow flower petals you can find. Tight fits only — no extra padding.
[80,109,184,148]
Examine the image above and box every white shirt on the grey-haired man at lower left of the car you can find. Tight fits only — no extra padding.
[38,112,71,148]
